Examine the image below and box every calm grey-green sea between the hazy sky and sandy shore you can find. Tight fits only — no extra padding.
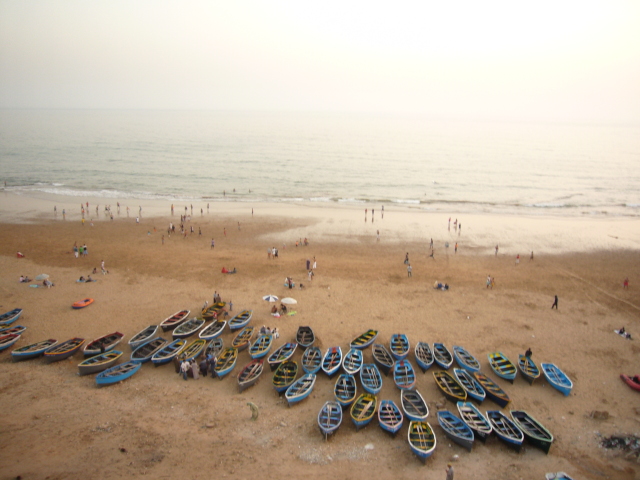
[0,110,640,217]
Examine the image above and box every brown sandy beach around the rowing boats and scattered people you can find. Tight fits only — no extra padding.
[0,193,640,480]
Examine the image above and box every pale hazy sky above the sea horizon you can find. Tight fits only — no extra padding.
[0,0,640,122]
